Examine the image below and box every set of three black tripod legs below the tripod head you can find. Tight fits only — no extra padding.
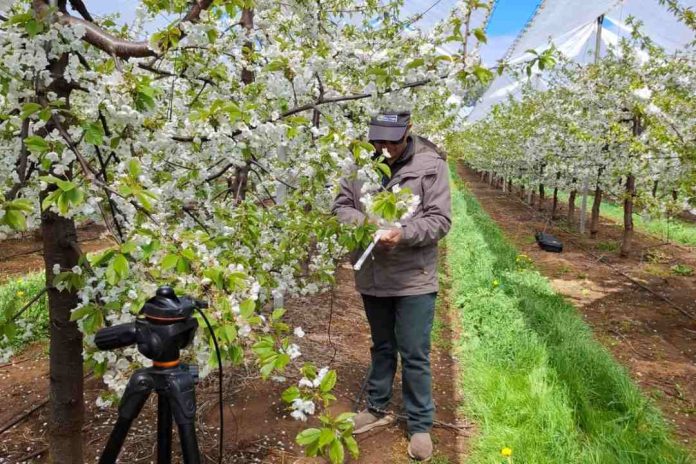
[99,365,200,464]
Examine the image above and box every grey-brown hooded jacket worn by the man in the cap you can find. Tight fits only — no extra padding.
[332,136,452,296]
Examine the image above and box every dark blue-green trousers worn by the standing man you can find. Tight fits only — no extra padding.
[362,293,437,434]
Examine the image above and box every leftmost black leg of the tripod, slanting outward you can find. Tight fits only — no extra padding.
[99,371,154,464]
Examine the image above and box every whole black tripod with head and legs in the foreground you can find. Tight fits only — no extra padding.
[94,287,207,464]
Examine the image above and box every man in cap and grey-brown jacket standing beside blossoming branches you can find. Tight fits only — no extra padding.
[332,111,451,461]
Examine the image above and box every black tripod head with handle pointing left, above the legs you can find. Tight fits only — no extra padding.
[94,286,208,368]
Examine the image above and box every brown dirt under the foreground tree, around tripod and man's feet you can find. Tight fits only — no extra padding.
[0,256,471,464]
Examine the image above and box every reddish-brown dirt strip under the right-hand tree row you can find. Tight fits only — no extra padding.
[459,161,696,449]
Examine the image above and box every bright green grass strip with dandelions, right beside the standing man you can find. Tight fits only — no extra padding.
[447,164,694,464]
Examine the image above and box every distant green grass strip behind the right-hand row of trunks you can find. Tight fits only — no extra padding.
[558,192,696,246]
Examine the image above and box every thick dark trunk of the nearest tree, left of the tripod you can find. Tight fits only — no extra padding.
[41,201,84,464]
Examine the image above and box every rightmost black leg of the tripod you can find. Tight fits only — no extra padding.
[166,371,201,464]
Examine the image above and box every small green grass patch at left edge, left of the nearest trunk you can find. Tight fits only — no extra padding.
[0,272,48,360]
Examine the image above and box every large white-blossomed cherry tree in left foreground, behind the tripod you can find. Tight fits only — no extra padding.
[0,0,491,463]
